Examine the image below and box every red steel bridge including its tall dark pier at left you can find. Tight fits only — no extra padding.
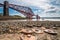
[0,1,40,18]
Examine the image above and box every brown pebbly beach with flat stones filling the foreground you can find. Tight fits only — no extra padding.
[0,21,60,40]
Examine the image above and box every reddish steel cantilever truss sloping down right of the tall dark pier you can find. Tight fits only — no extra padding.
[9,4,34,17]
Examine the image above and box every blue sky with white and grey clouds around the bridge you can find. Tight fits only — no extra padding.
[0,0,60,17]
